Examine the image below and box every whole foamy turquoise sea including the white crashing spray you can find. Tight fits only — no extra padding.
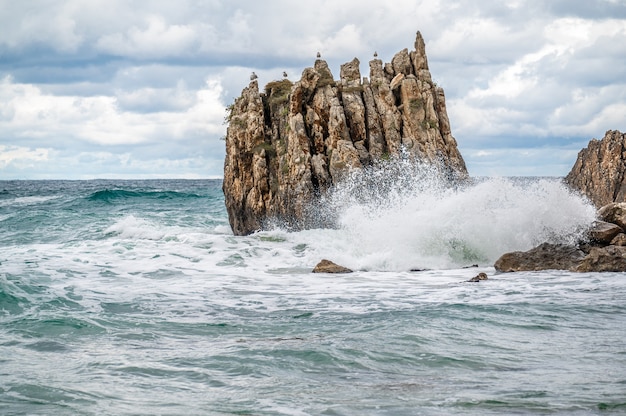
[0,174,626,415]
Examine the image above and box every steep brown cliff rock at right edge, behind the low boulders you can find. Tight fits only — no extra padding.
[565,130,626,207]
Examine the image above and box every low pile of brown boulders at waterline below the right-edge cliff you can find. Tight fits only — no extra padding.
[494,203,626,272]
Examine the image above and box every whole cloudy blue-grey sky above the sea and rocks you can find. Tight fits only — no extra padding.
[0,0,626,180]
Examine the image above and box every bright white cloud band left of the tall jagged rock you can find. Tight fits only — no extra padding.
[0,77,224,146]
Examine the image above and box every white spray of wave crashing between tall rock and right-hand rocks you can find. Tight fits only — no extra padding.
[304,160,595,270]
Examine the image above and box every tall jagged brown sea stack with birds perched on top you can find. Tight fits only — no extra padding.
[223,32,467,235]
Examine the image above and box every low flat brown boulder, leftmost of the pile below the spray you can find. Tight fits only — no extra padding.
[494,243,585,272]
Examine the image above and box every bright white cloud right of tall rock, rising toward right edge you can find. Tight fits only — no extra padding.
[448,13,626,159]
